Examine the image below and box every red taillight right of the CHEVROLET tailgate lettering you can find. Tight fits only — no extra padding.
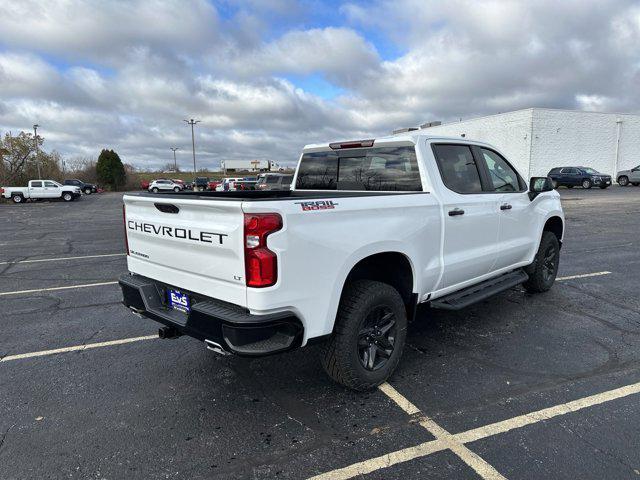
[244,213,282,288]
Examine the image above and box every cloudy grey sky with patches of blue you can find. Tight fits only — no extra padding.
[0,0,640,168]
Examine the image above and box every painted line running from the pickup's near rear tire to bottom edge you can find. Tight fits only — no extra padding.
[378,383,506,480]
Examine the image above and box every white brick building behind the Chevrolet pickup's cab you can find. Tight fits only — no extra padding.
[428,108,640,178]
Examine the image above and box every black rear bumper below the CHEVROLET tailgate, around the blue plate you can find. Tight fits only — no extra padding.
[119,274,303,357]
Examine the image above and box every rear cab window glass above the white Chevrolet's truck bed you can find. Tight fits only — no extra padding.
[295,146,423,192]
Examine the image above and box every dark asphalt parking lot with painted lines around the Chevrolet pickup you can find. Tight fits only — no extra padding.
[0,187,640,479]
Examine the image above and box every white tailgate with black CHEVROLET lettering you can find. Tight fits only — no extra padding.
[124,195,246,306]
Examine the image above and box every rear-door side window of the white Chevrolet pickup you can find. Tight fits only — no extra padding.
[433,144,482,193]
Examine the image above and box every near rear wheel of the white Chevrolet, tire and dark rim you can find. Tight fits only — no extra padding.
[322,280,407,391]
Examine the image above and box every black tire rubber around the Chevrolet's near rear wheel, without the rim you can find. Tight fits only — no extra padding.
[321,280,407,391]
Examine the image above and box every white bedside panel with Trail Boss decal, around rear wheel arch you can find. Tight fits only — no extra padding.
[243,193,441,342]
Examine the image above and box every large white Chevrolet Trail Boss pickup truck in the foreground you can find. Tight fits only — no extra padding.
[120,130,564,390]
